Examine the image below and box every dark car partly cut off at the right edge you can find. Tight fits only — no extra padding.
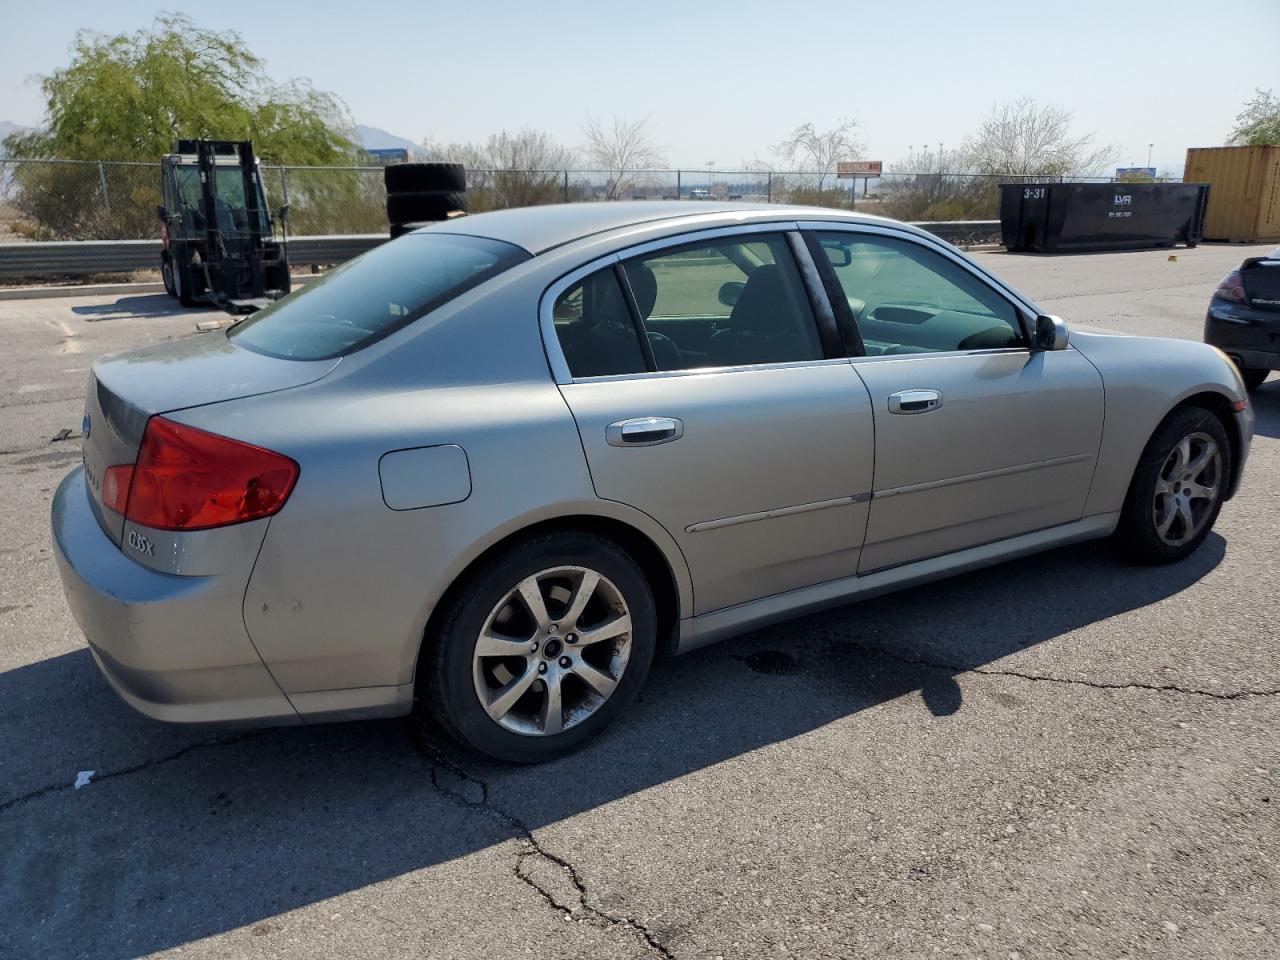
[1204,247,1280,390]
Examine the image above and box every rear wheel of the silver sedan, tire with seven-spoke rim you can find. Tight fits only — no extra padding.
[417,530,658,763]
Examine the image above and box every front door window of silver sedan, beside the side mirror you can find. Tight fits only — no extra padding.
[818,232,1027,356]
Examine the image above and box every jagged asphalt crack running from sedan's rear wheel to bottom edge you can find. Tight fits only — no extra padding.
[413,733,676,960]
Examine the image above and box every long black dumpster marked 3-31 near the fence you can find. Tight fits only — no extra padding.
[1000,183,1208,252]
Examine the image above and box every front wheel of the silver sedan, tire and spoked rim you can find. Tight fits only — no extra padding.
[1115,407,1233,563]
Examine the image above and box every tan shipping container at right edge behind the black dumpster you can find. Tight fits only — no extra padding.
[1185,146,1280,243]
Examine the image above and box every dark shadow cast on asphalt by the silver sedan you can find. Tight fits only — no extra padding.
[0,534,1225,960]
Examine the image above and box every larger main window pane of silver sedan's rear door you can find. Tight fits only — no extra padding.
[626,234,823,370]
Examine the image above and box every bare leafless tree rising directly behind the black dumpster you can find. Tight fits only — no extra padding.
[963,97,1116,179]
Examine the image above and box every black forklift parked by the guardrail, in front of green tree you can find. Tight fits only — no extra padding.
[156,140,289,314]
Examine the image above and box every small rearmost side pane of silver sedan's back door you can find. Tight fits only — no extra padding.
[552,268,646,378]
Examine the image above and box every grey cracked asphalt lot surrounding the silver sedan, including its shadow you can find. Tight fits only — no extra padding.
[0,246,1280,960]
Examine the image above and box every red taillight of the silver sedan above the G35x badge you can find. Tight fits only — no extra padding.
[102,417,298,530]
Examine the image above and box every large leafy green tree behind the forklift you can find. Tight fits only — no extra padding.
[5,14,358,239]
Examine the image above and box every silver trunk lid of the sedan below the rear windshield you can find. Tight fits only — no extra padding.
[82,334,340,543]
